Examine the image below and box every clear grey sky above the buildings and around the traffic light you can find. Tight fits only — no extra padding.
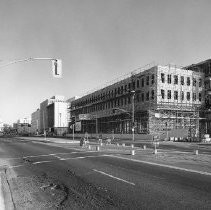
[0,0,211,123]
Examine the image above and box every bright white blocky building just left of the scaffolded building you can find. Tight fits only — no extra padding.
[40,96,68,135]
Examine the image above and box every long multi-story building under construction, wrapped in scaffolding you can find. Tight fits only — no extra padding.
[71,65,204,140]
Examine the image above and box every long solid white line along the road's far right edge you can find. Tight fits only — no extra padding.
[104,155,211,176]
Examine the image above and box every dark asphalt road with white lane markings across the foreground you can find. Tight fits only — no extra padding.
[0,138,211,209]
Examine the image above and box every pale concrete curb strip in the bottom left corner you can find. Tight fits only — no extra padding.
[0,172,15,210]
